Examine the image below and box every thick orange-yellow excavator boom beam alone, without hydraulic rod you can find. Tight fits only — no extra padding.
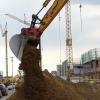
[39,0,69,33]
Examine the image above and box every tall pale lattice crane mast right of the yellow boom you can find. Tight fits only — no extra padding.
[65,0,73,81]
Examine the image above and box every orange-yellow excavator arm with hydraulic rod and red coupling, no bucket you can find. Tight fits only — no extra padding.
[22,0,69,39]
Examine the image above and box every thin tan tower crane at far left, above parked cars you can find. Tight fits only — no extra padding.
[0,22,8,77]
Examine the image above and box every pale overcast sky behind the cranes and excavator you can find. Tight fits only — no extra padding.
[0,0,100,75]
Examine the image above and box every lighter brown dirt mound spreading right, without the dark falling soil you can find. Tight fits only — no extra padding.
[8,70,100,100]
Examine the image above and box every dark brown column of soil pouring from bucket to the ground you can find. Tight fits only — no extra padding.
[7,40,46,100]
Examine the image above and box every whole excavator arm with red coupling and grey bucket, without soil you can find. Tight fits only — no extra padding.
[9,0,69,60]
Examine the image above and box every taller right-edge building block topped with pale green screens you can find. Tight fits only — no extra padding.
[81,48,100,79]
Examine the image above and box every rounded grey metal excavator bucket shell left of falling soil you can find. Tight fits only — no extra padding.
[9,34,28,60]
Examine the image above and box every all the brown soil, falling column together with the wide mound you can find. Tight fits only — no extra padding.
[7,39,100,100]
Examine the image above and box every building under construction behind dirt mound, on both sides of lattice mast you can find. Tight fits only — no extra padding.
[57,48,100,79]
